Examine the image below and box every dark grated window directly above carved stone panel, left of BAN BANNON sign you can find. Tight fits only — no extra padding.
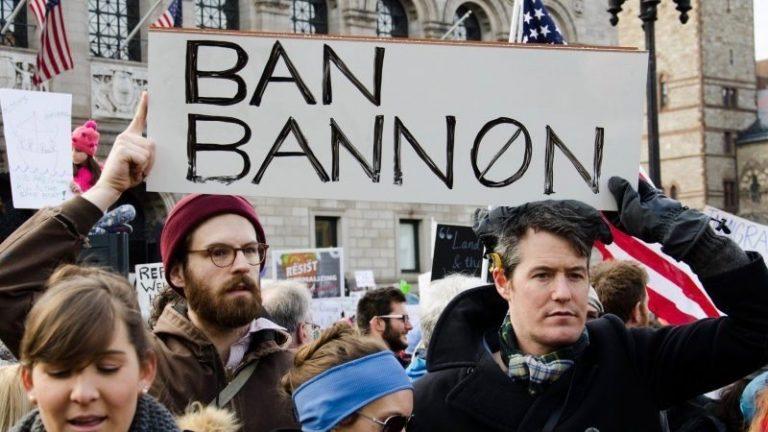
[88,0,141,60]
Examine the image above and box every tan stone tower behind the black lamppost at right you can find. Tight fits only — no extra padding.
[618,0,756,212]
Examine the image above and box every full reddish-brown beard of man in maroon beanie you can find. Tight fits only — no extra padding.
[184,267,262,329]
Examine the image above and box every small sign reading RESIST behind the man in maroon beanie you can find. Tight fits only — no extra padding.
[272,248,344,298]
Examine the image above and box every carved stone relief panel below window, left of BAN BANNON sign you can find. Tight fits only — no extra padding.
[91,59,147,119]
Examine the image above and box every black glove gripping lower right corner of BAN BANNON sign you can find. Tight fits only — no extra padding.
[608,177,709,260]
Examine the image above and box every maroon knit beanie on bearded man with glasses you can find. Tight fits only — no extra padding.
[160,194,267,296]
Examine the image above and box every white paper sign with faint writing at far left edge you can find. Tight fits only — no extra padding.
[0,89,72,208]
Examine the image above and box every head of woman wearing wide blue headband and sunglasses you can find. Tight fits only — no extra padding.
[282,323,413,432]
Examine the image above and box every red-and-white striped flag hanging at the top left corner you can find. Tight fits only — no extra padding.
[29,0,75,85]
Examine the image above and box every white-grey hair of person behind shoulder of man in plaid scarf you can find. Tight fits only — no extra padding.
[419,274,483,348]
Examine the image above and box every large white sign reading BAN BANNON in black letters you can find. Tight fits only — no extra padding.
[147,29,647,209]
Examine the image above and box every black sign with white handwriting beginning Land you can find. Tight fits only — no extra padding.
[432,224,484,280]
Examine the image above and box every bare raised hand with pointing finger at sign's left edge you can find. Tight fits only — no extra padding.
[83,92,155,210]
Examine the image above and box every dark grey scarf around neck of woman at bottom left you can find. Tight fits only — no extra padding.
[11,395,179,432]
